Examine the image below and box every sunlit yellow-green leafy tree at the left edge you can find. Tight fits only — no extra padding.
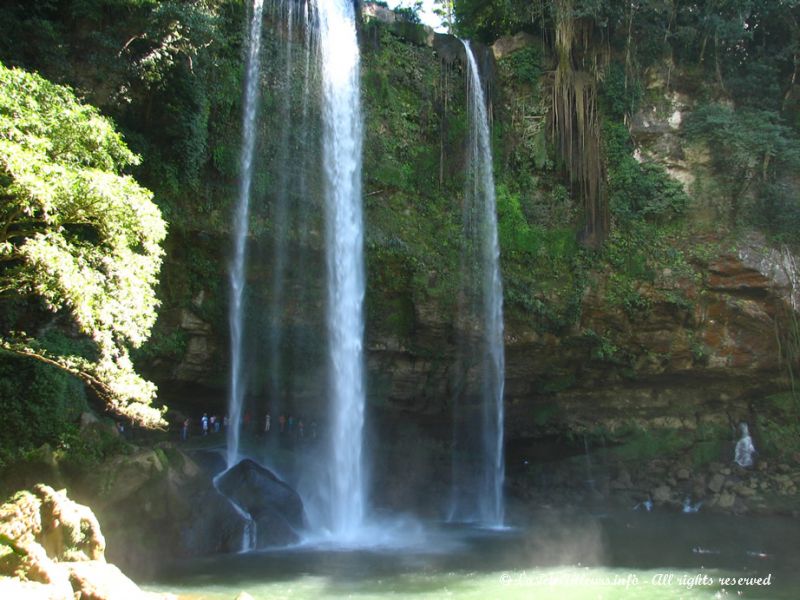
[0,63,166,426]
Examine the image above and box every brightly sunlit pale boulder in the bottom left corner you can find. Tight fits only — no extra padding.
[0,484,166,600]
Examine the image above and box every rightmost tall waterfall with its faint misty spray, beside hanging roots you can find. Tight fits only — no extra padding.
[452,41,505,527]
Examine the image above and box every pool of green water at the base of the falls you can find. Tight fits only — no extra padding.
[144,512,800,600]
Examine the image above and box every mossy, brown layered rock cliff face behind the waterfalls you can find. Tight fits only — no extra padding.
[130,19,797,509]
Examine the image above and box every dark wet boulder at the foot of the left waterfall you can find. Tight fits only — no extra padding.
[217,458,303,548]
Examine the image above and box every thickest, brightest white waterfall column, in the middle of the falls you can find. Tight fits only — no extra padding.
[317,0,365,541]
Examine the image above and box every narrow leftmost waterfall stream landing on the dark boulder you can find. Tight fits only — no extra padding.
[227,0,264,468]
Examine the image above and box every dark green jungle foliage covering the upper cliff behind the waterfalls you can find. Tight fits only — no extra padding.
[0,0,800,466]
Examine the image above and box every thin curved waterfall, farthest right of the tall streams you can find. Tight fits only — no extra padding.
[464,41,505,527]
